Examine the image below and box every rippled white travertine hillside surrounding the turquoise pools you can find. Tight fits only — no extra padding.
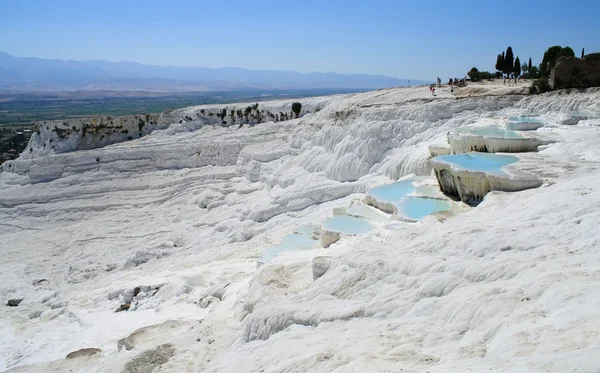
[0,84,600,373]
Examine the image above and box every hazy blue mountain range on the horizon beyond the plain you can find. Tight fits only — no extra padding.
[0,51,427,91]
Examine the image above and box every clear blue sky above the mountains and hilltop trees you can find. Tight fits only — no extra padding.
[0,0,600,80]
